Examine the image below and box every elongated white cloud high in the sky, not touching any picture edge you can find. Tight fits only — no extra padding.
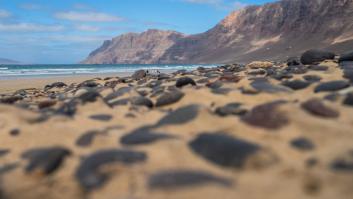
[54,11,123,22]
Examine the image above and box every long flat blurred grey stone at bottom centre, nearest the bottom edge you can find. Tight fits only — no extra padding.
[148,170,232,190]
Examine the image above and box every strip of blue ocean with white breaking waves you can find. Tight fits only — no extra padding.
[0,64,217,79]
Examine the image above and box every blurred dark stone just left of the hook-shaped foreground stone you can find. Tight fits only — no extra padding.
[22,147,71,175]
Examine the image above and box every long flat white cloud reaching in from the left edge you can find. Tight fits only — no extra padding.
[0,23,65,32]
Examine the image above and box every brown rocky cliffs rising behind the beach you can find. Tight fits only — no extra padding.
[85,0,353,63]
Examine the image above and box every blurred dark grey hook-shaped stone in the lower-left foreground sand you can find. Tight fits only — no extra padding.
[75,149,147,191]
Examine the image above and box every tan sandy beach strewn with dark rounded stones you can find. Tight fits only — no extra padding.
[0,61,353,199]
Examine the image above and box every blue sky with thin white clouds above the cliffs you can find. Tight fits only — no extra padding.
[0,0,274,64]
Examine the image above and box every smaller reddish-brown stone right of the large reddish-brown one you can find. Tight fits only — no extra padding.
[301,99,339,118]
